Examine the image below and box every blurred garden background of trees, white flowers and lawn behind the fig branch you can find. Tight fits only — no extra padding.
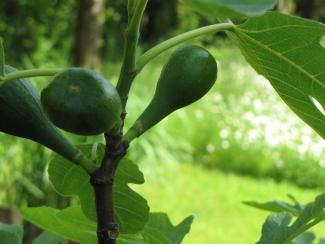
[0,0,325,244]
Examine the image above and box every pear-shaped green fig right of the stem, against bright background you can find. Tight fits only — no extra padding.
[125,45,217,138]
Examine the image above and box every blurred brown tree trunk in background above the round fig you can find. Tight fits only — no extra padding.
[74,0,105,70]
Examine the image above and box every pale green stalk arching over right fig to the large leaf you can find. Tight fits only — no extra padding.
[136,23,235,71]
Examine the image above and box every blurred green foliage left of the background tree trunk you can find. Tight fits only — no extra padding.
[0,0,77,67]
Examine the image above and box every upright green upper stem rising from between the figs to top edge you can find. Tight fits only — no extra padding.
[116,0,148,112]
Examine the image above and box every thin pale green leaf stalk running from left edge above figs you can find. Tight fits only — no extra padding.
[0,68,63,84]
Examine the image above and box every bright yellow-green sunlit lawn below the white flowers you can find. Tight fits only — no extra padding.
[136,163,324,244]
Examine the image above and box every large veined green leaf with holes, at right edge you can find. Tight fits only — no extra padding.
[235,13,325,138]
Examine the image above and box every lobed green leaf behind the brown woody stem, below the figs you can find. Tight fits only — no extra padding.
[48,144,149,234]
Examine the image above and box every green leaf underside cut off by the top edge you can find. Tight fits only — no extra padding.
[184,0,277,18]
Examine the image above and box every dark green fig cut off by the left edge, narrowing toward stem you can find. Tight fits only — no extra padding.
[0,65,87,164]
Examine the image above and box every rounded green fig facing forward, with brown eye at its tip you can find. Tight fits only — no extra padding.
[41,68,122,135]
